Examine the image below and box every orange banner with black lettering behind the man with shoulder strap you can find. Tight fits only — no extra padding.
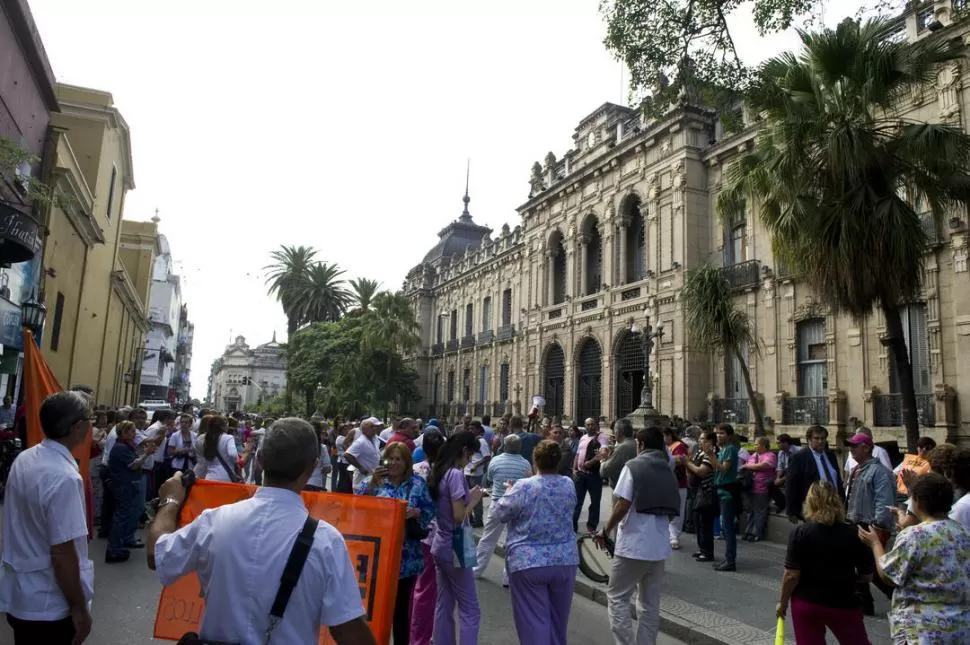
[155,480,407,645]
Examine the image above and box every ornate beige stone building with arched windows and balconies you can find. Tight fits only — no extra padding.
[405,2,970,443]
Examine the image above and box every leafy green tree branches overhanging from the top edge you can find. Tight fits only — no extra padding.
[600,0,904,117]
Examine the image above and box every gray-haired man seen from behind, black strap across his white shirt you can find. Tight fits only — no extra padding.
[148,418,374,645]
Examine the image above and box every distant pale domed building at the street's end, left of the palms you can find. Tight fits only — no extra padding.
[208,333,286,412]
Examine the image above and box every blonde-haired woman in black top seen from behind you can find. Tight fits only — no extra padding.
[777,482,873,645]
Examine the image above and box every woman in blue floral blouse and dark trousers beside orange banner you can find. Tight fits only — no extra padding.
[357,441,435,645]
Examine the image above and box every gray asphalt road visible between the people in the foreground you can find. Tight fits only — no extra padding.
[0,540,682,645]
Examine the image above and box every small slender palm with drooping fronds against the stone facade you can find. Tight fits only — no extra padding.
[681,264,765,437]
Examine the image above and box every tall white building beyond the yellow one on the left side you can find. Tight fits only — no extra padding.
[139,231,182,404]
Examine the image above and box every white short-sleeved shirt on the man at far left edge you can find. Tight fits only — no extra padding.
[0,439,94,621]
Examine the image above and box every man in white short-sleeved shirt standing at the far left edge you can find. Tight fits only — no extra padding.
[0,392,94,645]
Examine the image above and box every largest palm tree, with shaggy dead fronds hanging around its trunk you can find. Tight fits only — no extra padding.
[718,20,970,452]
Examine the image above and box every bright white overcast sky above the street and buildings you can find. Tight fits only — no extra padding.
[30,0,858,399]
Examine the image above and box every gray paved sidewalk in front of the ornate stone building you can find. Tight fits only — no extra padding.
[476,488,892,645]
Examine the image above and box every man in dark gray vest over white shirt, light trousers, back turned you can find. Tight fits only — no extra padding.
[596,427,680,645]
